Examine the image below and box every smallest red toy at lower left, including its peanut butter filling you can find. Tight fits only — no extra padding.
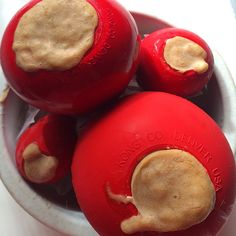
[16,115,77,184]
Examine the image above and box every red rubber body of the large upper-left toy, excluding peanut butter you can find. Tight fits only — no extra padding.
[1,0,140,114]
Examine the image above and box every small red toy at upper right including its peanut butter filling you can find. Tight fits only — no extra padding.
[138,28,214,97]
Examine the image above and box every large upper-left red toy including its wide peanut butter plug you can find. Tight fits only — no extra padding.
[1,0,141,114]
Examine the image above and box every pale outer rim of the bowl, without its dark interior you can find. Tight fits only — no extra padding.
[0,12,236,236]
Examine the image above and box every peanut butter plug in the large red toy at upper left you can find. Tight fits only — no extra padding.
[13,0,98,72]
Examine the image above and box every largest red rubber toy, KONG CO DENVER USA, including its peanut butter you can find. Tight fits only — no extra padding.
[72,92,236,236]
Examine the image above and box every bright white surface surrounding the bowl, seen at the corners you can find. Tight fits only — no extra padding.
[0,0,236,236]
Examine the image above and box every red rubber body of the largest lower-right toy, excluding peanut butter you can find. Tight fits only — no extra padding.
[72,92,236,236]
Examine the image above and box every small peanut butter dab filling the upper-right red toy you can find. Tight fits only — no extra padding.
[164,36,209,74]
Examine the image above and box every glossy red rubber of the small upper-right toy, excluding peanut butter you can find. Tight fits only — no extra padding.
[138,28,214,97]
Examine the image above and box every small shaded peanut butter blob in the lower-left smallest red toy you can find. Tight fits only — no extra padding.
[22,143,59,183]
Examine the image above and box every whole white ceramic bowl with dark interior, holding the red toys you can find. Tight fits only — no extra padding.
[0,13,236,236]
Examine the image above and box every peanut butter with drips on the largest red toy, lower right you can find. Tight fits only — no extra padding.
[108,149,215,234]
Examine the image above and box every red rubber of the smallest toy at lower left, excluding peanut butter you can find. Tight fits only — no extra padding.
[15,115,77,184]
